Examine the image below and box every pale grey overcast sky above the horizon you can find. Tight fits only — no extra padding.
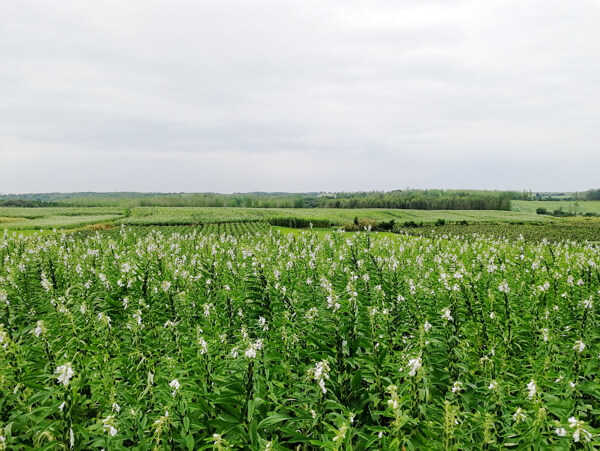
[0,0,600,193]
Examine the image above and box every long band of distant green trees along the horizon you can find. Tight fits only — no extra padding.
[0,189,532,210]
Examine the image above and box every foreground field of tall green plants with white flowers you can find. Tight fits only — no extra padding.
[0,223,600,450]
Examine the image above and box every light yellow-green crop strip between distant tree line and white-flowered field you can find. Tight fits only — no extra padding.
[0,207,554,235]
